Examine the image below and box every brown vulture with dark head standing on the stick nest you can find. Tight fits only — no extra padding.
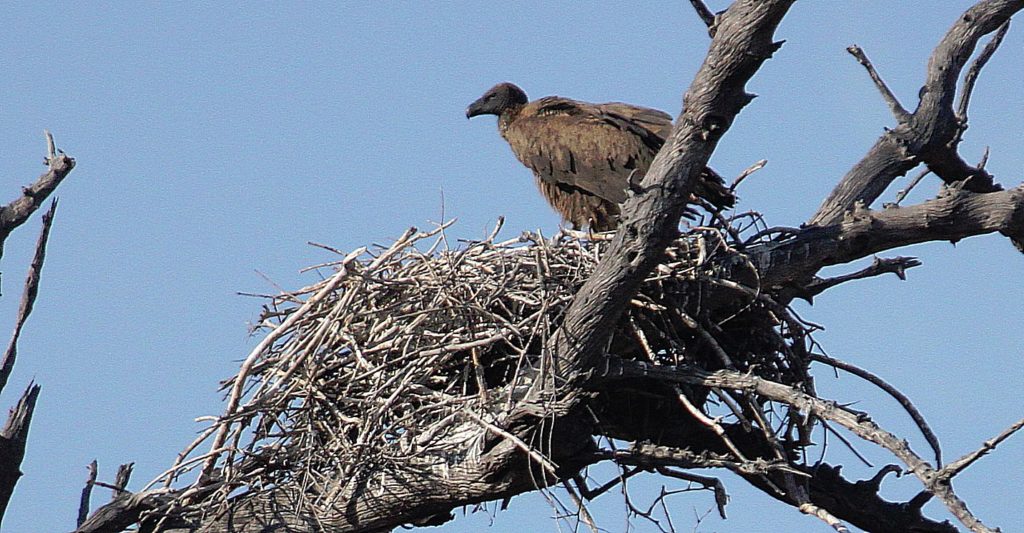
[466,83,735,231]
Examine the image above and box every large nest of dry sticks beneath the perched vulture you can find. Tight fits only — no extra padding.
[155,212,807,516]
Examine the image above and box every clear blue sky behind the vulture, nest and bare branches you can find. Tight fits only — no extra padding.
[0,1,1024,533]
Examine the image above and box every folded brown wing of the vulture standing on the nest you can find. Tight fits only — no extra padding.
[503,96,672,204]
